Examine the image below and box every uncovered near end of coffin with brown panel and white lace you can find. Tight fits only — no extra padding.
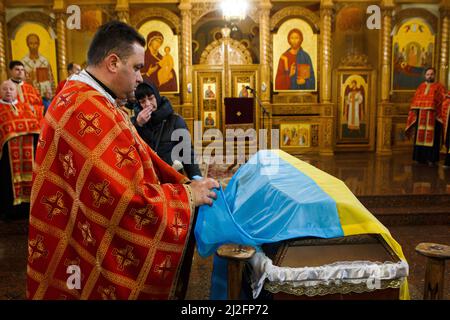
[247,234,408,300]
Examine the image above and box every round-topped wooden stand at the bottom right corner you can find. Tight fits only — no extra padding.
[416,242,450,300]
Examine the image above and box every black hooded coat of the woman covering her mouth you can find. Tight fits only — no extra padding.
[131,96,201,179]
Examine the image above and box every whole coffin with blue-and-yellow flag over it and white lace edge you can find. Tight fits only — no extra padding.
[195,150,409,299]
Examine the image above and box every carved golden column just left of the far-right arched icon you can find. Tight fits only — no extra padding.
[376,0,394,155]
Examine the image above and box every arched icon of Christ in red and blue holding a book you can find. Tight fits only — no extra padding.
[274,19,317,91]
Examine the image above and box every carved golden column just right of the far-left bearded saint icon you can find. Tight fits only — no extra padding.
[53,1,67,81]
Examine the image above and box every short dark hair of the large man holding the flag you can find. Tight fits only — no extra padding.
[87,20,145,66]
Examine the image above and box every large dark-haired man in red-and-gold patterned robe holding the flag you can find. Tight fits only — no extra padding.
[27,21,219,300]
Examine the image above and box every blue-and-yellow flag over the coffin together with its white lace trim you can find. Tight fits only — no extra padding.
[195,150,409,299]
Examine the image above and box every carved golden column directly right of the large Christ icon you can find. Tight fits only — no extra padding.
[319,0,335,155]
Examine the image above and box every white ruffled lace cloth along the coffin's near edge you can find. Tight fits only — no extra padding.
[249,252,409,298]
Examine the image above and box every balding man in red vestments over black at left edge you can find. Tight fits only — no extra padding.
[0,80,40,220]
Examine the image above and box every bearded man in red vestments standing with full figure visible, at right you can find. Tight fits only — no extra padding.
[405,68,446,166]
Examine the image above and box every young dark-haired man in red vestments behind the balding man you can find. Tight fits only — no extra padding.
[9,60,44,117]
